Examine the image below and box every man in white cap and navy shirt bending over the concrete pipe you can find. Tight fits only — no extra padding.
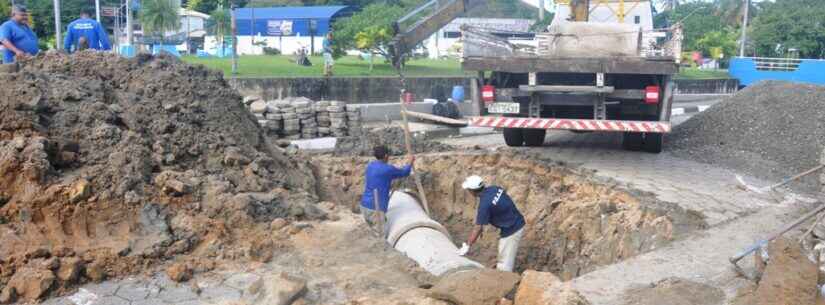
[458,176,524,272]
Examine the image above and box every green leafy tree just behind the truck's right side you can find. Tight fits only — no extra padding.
[653,0,724,50]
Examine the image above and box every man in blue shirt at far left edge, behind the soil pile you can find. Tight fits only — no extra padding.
[0,5,40,64]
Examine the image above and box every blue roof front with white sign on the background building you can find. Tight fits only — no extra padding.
[235,6,352,36]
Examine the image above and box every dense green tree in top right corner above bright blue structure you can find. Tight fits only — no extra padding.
[748,0,825,58]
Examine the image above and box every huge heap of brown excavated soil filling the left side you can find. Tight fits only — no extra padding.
[0,52,324,303]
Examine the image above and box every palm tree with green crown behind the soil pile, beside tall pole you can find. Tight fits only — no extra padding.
[140,0,180,42]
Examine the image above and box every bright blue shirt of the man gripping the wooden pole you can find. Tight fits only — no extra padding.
[361,160,412,212]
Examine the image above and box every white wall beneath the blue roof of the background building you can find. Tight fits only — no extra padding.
[204,36,324,55]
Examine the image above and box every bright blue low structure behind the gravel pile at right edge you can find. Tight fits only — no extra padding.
[728,57,825,86]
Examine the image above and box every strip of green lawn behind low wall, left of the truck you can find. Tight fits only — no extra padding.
[183,55,472,77]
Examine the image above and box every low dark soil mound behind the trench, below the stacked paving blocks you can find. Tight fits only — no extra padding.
[334,126,455,156]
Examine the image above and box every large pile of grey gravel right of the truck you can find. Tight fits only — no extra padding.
[668,81,825,189]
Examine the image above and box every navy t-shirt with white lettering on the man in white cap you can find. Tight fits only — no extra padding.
[476,186,524,238]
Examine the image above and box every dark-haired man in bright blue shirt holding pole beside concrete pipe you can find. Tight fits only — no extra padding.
[361,145,415,229]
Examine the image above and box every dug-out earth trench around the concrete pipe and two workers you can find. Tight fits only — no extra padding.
[314,153,706,279]
